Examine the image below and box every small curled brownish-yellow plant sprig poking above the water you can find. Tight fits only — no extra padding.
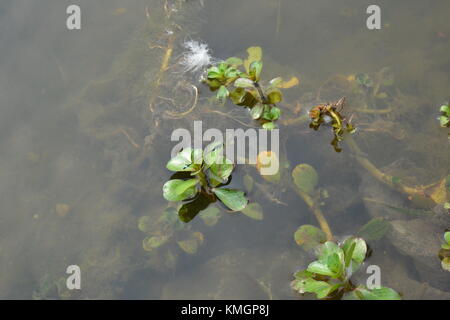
[309,97,356,152]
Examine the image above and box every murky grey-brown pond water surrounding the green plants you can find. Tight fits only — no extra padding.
[0,0,450,299]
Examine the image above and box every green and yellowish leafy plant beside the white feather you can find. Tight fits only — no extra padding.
[205,47,298,130]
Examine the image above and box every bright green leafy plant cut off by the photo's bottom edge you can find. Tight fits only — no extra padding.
[291,237,401,300]
